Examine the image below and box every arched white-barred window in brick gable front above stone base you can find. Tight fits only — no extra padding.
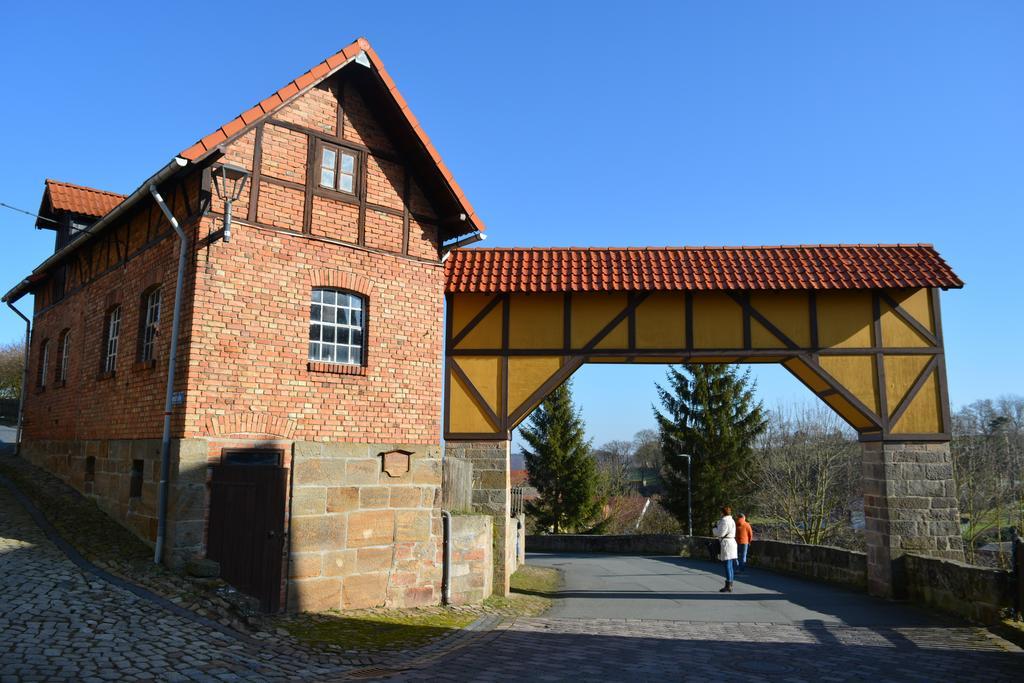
[309,288,366,366]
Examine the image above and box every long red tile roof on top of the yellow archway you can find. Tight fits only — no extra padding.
[444,245,964,293]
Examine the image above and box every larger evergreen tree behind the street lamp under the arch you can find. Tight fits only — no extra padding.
[654,365,766,536]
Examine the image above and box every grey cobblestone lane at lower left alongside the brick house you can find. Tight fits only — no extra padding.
[0,486,350,683]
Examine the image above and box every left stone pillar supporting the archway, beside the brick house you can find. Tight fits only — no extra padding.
[444,440,516,596]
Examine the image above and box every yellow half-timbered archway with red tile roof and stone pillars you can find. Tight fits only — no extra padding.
[444,245,963,595]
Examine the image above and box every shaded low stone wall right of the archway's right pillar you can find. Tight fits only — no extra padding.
[901,553,1015,624]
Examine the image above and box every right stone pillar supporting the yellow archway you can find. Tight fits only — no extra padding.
[862,441,964,598]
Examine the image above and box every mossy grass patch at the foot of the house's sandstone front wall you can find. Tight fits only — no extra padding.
[279,607,478,652]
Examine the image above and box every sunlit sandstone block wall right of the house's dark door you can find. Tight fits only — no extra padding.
[288,441,442,611]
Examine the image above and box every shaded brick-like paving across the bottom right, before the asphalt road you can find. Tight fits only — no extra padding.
[390,618,1024,683]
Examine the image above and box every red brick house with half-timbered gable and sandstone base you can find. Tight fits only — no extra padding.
[4,39,483,609]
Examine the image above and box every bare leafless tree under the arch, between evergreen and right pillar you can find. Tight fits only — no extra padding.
[751,407,860,545]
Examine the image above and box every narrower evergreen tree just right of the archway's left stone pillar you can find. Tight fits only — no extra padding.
[519,382,601,533]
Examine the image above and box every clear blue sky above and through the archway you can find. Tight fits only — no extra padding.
[0,0,1024,442]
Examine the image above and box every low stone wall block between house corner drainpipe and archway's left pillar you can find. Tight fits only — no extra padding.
[451,515,495,605]
